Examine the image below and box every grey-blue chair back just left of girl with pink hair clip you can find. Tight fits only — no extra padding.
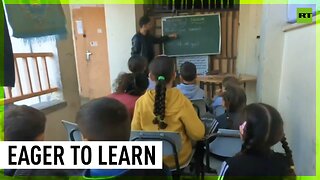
[205,129,243,173]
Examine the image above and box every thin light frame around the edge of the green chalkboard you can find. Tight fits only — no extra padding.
[161,13,222,57]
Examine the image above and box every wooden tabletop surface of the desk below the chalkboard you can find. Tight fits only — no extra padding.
[197,74,257,84]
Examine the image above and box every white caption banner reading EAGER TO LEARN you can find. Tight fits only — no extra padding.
[0,141,162,169]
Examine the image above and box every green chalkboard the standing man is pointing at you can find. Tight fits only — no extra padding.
[162,14,221,56]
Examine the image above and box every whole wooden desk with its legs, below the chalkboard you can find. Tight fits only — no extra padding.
[197,74,257,98]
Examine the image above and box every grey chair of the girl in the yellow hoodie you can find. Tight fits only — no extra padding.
[130,131,199,177]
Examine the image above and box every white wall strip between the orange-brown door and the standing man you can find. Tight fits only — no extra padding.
[105,4,136,91]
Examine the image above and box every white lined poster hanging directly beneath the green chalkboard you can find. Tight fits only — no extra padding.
[177,56,209,75]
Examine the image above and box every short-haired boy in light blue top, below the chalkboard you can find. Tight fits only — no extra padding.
[177,61,205,100]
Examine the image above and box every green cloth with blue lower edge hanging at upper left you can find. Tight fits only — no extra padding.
[6,4,67,39]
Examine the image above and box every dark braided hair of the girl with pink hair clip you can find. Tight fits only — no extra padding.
[241,103,295,176]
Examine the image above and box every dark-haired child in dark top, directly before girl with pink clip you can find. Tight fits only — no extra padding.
[216,85,247,130]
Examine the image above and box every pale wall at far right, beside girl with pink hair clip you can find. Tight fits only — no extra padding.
[278,24,320,176]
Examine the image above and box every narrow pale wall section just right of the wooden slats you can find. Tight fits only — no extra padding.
[257,5,287,106]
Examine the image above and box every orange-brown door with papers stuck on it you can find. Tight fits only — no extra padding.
[72,7,111,99]
